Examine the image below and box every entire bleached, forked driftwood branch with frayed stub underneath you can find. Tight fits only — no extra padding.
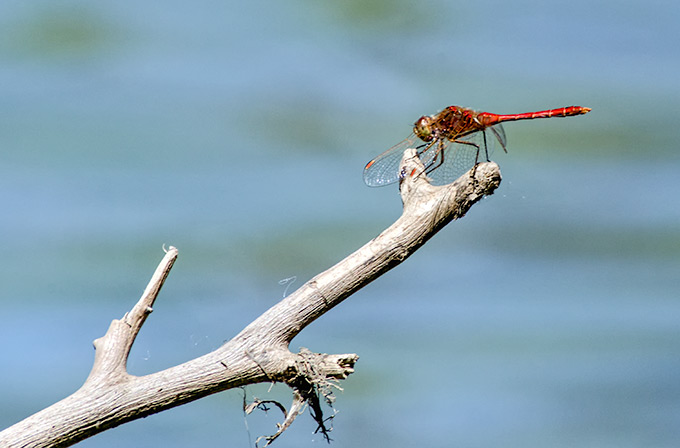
[0,150,501,447]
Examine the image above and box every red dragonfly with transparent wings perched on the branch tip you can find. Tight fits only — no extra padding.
[364,106,590,187]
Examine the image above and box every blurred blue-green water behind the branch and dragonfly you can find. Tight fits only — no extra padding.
[0,0,680,448]
